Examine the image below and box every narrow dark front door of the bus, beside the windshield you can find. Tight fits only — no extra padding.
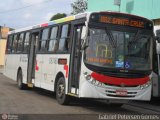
[68,25,83,95]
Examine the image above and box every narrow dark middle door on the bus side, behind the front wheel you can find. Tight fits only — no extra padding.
[27,32,40,87]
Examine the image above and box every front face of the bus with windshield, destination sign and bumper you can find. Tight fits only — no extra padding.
[76,12,153,102]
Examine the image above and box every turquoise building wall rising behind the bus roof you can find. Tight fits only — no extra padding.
[88,0,160,32]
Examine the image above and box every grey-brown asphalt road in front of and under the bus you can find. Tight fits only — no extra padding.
[0,74,160,119]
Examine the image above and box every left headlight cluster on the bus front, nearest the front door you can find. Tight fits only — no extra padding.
[84,72,103,87]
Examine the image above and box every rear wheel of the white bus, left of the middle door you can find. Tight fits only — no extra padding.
[17,70,26,90]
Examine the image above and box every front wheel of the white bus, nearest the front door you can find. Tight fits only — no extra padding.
[56,77,70,105]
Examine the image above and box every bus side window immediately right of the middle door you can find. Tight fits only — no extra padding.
[39,28,49,52]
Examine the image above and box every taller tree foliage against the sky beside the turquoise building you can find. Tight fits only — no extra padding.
[71,0,88,15]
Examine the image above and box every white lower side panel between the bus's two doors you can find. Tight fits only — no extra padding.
[35,54,70,93]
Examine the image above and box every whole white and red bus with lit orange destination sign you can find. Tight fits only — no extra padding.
[4,12,154,104]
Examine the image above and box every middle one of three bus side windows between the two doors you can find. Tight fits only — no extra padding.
[48,27,58,52]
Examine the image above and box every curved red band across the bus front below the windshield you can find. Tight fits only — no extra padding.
[91,72,150,86]
